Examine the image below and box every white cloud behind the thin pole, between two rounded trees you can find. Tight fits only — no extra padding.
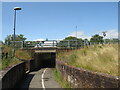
[68,31,91,40]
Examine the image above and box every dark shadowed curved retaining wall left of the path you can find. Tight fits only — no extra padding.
[2,62,25,89]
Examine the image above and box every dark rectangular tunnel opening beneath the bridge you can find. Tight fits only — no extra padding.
[34,52,56,69]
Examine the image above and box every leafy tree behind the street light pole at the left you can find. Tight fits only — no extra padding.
[5,34,27,45]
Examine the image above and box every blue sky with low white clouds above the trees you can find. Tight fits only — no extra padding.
[2,2,118,40]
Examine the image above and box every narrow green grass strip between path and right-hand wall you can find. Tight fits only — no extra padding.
[54,68,71,88]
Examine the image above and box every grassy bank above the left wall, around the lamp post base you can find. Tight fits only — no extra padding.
[0,45,32,70]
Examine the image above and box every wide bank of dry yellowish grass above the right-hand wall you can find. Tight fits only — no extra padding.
[57,44,118,76]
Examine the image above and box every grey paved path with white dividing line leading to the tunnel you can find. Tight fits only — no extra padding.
[20,68,61,90]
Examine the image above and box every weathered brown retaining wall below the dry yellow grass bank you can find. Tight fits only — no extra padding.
[56,61,120,88]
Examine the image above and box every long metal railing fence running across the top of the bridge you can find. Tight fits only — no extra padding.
[6,40,119,48]
